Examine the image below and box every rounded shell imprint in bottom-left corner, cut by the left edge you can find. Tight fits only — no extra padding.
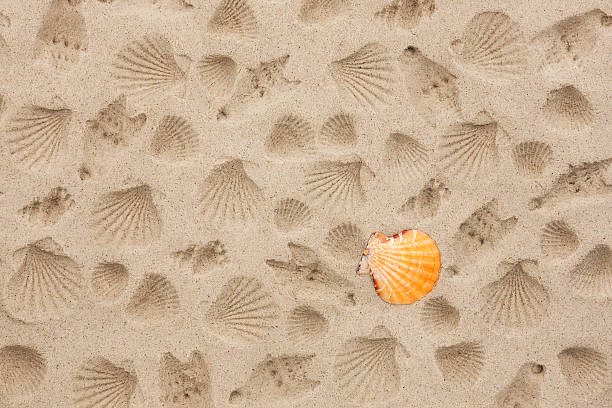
[0,345,47,401]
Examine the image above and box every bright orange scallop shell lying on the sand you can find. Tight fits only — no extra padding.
[357,230,441,305]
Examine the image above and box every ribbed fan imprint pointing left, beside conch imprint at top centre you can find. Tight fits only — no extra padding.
[328,43,394,106]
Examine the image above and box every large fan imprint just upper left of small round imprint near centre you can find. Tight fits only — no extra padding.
[200,159,262,224]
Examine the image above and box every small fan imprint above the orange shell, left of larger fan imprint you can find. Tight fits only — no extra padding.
[384,133,429,183]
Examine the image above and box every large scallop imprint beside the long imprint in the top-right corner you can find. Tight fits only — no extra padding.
[451,11,530,80]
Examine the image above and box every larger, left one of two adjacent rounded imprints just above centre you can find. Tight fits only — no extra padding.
[265,115,315,159]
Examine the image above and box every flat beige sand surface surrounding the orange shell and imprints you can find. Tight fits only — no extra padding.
[0,0,612,407]
